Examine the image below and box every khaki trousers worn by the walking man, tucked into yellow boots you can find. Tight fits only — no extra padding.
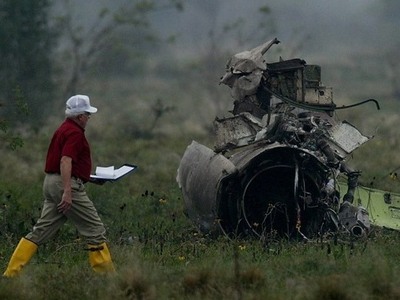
[25,174,106,245]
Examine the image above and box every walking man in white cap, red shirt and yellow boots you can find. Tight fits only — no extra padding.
[3,95,115,277]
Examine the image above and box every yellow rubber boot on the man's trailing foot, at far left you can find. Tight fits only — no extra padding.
[3,238,38,277]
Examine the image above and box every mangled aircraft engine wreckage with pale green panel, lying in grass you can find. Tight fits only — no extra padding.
[177,39,400,239]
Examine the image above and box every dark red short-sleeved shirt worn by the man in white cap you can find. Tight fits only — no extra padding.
[45,118,92,182]
